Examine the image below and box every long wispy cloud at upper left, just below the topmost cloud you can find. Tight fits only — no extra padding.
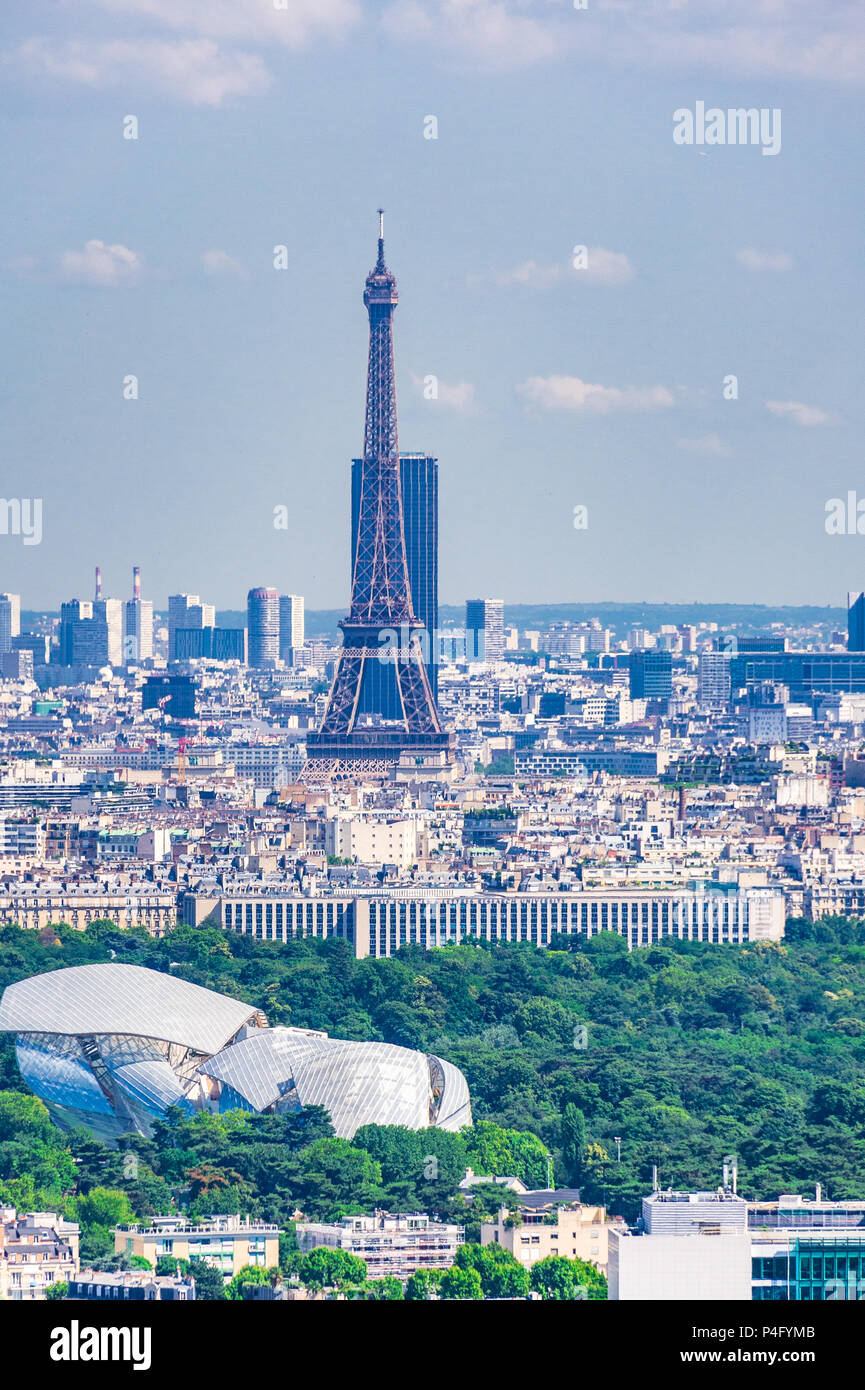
[4,39,270,106]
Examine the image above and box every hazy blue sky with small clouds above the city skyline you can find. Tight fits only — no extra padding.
[0,0,865,607]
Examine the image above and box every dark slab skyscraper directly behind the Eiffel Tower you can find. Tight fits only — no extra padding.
[352,453,439,700]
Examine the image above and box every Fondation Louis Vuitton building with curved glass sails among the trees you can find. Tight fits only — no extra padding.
[0,963,471,1140]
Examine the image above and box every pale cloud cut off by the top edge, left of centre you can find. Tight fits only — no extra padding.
[89,0,362,49]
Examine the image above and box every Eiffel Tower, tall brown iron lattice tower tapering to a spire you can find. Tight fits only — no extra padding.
[307,213,453,777]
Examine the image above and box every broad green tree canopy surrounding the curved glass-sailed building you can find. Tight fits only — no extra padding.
[0,919,865,1243]
